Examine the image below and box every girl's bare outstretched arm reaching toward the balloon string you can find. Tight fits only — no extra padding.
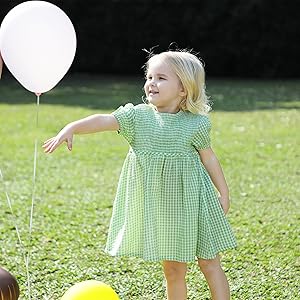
[43,114,119,153]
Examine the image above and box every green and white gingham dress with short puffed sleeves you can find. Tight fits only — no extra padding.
[105,103,236,262]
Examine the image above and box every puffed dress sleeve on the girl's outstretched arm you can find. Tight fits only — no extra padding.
[112,103,135,144]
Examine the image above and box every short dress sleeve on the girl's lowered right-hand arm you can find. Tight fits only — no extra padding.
[192,116,211,150]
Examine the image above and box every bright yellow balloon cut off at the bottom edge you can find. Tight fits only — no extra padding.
[61,280,120,300]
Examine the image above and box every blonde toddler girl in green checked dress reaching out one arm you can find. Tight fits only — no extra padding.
[43,51,236,300]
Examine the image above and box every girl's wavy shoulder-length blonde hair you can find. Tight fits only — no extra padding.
[145,50,211,114]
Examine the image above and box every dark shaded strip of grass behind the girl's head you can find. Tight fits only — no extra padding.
[0,72,300,111]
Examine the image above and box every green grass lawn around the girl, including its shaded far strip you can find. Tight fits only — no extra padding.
[0,76,300,300]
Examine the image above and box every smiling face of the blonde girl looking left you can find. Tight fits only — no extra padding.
[144,58,185,113]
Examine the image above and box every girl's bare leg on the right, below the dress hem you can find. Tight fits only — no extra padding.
[198,255,230,300]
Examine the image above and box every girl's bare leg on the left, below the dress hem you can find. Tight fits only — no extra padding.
[163,260,187,300]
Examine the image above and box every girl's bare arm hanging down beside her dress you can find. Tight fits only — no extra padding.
[199,148,229,214]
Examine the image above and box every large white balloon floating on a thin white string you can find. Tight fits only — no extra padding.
[0,1,76,93]
